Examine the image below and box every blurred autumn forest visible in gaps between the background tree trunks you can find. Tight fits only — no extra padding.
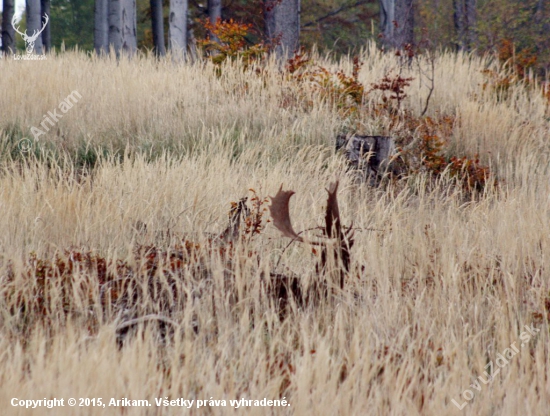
[2,0,550,78]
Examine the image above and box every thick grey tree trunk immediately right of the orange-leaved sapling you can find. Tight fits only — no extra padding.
[265,0,300,58]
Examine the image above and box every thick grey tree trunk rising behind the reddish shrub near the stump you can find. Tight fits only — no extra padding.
[380,0,414,49]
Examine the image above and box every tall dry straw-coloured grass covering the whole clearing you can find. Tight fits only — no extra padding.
[0,48,550,415]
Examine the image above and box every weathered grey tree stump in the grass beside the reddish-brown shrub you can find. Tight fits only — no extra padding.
[336,134,398,185]
